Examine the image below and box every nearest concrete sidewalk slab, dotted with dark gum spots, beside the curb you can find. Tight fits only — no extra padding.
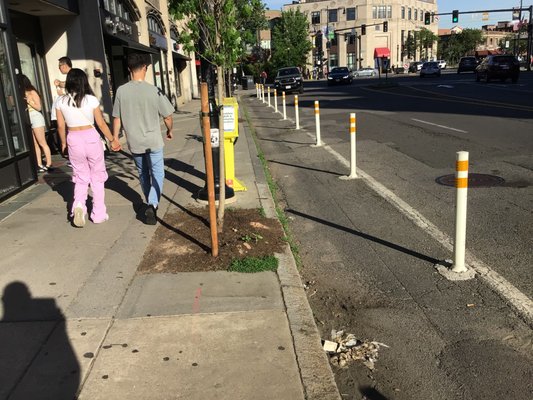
[79,311,304,400]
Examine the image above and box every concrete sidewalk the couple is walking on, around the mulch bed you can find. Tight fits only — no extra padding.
[0,95,340,400]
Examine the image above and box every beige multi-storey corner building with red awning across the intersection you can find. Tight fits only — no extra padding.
[283,0,438,71]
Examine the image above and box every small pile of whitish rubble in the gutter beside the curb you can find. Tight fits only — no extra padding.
[323,329,389,370]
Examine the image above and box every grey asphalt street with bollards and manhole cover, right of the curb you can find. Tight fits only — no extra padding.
[245,70,533,400]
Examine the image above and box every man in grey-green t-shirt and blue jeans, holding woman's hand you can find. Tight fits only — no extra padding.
[113,53,174,225]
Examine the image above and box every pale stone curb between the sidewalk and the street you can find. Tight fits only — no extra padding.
[237,95,341,400]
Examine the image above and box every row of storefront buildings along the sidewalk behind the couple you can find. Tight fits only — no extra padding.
[0,0,197,201]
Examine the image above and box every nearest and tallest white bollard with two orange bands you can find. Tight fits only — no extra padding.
[452,151,468,272]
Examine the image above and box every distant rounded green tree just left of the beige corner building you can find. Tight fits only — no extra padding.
[272,9,313,69]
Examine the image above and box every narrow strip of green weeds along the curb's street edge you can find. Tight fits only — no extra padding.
[241,107,302,268]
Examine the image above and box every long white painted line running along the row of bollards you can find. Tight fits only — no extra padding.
[296,126,533,327]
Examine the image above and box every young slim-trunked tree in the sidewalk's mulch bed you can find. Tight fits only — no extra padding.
[168,0,243,233]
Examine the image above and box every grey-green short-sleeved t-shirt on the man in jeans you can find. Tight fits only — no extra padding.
[113,81,174,154]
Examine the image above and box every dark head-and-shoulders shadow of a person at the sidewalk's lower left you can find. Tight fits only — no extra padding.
[0,281,80,400]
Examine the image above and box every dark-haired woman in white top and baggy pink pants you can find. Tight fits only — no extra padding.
[56,68,120,228]
